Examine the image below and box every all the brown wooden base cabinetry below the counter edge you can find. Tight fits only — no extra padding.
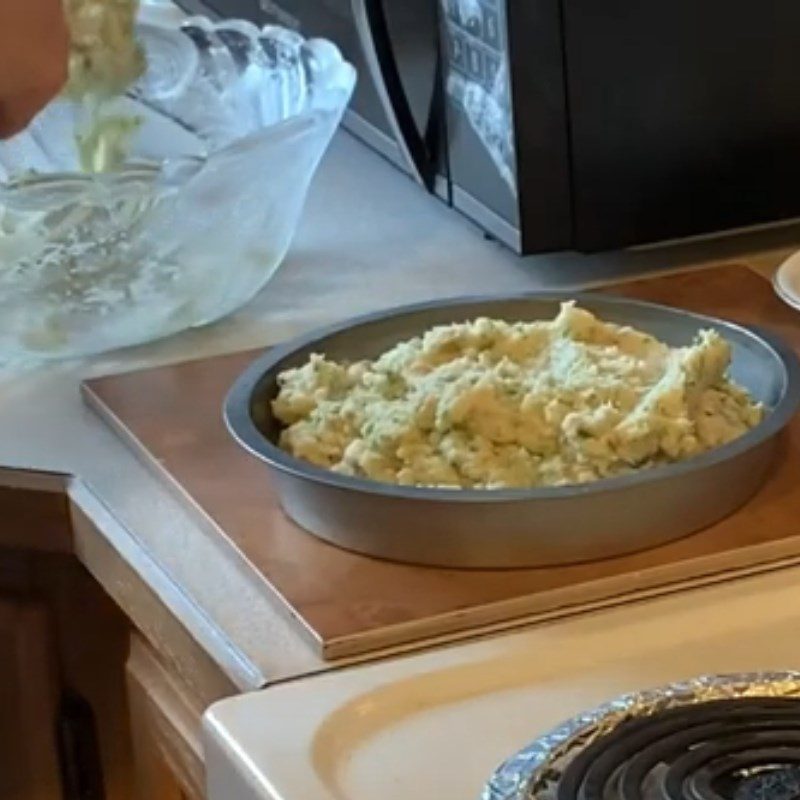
[0,549,205,800]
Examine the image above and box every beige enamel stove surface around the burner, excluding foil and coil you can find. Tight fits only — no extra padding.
[206,569,800,800]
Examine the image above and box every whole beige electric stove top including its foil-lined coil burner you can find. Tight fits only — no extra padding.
[206,568,800,800]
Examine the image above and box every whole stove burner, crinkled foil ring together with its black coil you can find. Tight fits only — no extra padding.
[481,672,800,800]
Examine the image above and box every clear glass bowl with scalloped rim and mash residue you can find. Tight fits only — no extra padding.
[0,17,355,362]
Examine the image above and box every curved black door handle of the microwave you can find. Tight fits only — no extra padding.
[351,0,436,191]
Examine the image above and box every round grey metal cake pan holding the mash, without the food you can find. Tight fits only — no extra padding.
[224,292,800,568]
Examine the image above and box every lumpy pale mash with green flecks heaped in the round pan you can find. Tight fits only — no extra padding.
[273,303,764,489]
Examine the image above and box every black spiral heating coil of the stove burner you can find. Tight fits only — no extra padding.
[553,697,800,800]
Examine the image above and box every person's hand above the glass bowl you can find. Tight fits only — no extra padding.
[0,0,69,139]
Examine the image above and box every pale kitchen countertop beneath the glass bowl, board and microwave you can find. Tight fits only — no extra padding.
[0,128,800,689]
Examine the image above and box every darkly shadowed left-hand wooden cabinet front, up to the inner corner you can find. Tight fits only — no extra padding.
[0,549,135,800]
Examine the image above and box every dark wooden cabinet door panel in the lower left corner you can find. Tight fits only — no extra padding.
[0,598,62,800]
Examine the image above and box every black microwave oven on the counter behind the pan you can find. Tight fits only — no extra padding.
[173,0,800,254]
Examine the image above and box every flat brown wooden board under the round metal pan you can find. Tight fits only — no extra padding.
[83,266,800,658]
